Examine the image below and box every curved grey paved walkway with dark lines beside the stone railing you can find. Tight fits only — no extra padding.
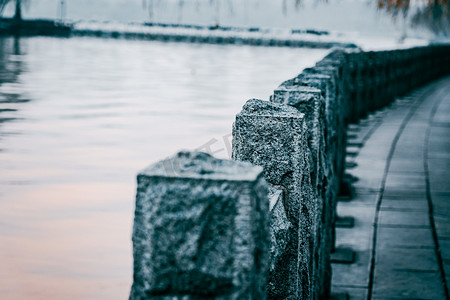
[332,77,450,300]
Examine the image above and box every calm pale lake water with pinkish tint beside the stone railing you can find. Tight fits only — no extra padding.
[0,37,327,299]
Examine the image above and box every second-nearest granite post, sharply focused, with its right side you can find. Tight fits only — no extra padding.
[233,99,316,299]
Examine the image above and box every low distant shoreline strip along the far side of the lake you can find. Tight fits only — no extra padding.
[0,18,357,49]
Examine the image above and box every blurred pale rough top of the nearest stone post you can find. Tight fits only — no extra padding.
[139,151,263,181]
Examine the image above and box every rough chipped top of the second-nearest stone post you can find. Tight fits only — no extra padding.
[238,99,305,119]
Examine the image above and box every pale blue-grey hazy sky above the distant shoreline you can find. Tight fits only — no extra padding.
[0,0,432,36]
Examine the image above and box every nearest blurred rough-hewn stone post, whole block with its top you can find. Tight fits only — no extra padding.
[130,152,269,299]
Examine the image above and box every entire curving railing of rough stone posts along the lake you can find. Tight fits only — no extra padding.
[130,46,450,299]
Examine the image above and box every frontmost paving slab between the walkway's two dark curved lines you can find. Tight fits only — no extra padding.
[373,268,445,300]
